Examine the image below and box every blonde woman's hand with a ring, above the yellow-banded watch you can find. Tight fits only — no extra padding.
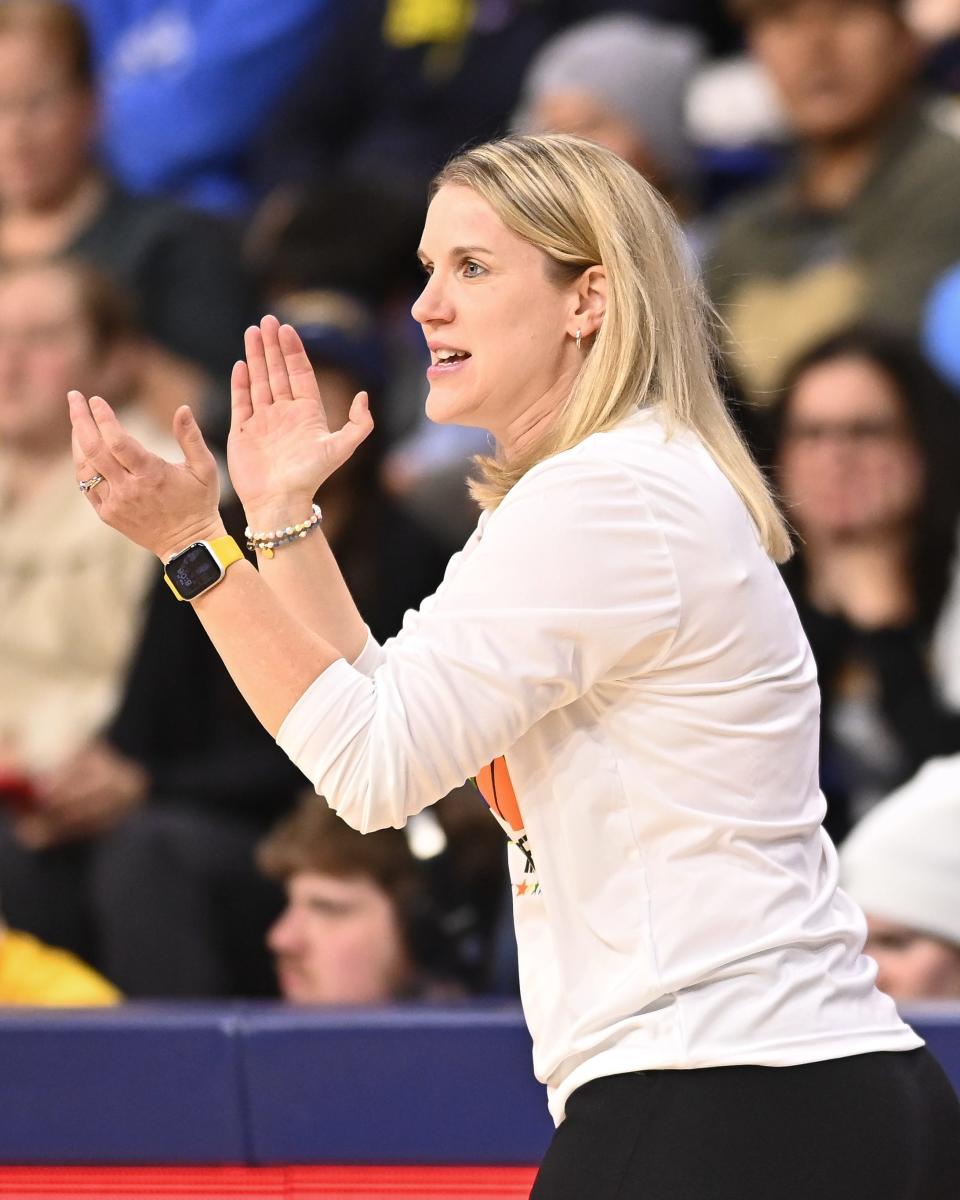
[67,391,223,563]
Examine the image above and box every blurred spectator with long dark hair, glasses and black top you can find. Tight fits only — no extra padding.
[774,330,960,839]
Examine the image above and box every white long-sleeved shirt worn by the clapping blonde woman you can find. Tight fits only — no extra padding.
[277,412,923,1123]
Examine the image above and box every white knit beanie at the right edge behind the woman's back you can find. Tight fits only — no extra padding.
[840,755,960,946]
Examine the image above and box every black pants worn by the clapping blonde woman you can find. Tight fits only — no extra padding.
[530,1050,960,1200]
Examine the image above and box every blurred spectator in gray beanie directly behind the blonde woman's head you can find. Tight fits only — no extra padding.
[514,13,703,217]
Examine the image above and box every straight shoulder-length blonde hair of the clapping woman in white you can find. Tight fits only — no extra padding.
[431,134,792,563]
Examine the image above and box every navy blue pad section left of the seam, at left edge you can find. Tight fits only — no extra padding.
[0,1004,247,1165]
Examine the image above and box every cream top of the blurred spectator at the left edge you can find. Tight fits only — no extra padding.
[0,408,180,774]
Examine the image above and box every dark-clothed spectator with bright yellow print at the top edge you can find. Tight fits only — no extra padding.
[250,0,564,198]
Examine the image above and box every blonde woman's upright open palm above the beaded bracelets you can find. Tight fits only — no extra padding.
[227,317,373,516]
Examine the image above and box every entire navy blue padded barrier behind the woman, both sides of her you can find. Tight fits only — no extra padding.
[0,1003,960,1165]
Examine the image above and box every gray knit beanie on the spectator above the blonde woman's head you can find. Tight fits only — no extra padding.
[514,13,703,182]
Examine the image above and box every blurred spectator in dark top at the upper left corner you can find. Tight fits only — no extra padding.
[0,0,250,432]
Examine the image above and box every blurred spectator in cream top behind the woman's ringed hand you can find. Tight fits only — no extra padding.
[0,262,175,801]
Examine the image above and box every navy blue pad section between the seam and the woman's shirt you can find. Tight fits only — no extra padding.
[242,1004,552,1164]
